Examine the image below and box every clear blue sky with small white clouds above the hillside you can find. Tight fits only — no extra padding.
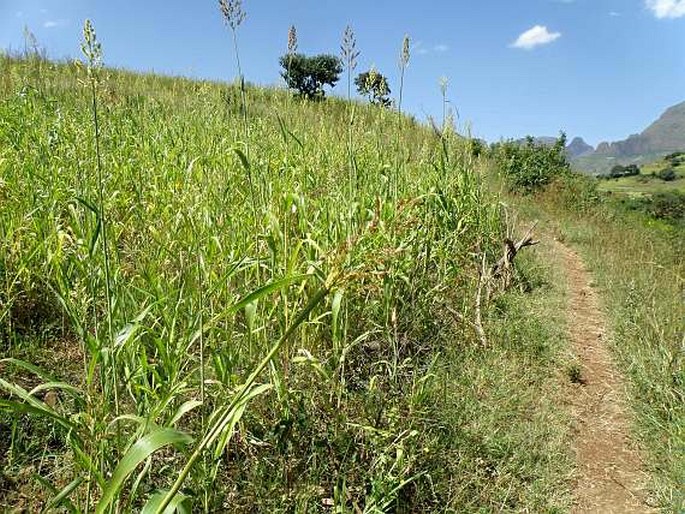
[0,0,685,144]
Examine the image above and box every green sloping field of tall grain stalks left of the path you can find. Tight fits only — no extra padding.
[0,57,571,512]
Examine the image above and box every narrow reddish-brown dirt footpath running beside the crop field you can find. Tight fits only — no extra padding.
[555,242,653,514]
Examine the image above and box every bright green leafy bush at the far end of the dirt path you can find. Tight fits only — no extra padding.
[494,133,570,194]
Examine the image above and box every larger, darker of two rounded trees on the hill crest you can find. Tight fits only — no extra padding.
[279,53,343,100]
